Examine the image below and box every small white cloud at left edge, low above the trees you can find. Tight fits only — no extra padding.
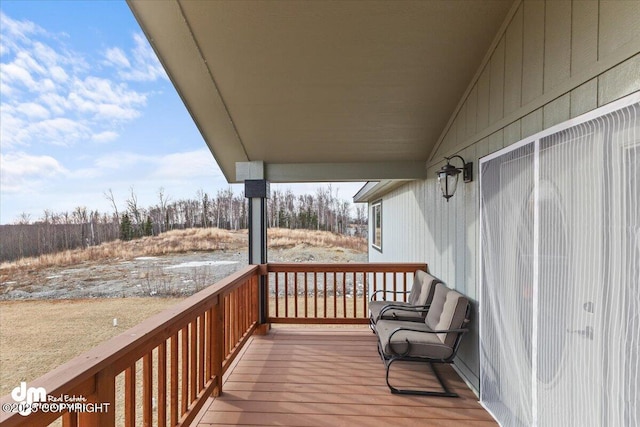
[0,152,68,193]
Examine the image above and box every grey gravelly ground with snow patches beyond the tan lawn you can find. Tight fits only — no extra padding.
[0,244,367,300]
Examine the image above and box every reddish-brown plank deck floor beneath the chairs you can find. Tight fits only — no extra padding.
[197,327,497,427]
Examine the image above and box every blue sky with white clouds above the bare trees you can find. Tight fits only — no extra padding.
[0,0,362,224]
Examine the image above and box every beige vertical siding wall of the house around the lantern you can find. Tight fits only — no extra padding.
[369,0,640,388]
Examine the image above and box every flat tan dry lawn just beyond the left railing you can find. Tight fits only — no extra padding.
[0,298,178,395]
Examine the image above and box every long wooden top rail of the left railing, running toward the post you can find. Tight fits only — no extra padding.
[0,265,259,410]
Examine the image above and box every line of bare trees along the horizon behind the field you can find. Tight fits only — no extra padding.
[0,186,367,262]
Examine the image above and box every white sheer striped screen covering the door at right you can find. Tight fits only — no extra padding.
[480,103,640,426]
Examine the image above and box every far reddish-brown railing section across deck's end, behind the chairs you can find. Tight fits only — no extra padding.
[267,263,427,324]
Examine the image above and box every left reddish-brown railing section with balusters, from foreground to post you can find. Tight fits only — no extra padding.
[0,266,260,427]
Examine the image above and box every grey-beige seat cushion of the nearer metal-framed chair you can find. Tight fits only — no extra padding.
[376,320,453,359]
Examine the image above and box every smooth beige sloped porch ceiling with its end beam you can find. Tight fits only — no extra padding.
[128,0,513,182]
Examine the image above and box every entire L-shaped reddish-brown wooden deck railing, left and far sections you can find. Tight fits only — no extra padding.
[0,263,427,427]
